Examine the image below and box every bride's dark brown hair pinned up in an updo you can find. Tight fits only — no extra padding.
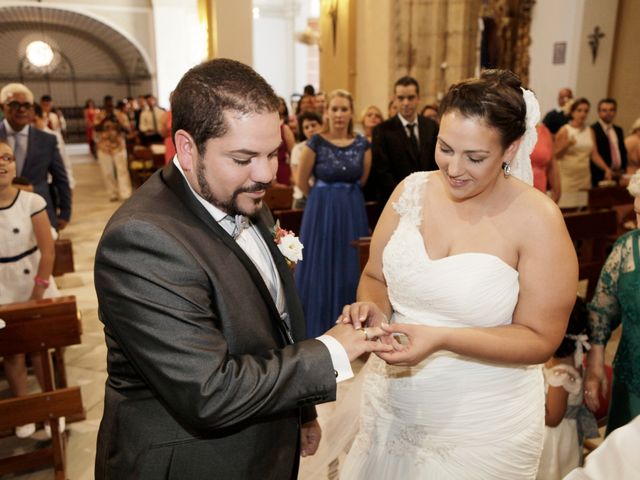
[439,70,527,149]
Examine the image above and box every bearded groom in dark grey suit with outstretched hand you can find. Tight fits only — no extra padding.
[95,59,389,480]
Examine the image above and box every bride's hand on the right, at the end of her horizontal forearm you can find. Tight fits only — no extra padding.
[376,323,442,367]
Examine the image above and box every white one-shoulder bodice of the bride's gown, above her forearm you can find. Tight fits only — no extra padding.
[383,172,519,327]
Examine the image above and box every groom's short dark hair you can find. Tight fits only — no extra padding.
[171,58,278,155]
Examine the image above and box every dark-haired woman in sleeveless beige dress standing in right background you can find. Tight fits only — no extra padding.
[554,98,613,207]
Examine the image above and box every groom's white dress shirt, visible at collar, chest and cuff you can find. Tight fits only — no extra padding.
[173,156,353,383]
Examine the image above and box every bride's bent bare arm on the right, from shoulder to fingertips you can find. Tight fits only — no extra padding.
[380,193,578,365]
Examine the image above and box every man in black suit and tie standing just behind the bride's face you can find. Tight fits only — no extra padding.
[366,76,438,208]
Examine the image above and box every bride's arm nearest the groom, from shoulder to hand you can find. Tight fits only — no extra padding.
[338,183,404,328]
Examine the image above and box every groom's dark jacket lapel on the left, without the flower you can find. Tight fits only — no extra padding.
[160,162,286,339]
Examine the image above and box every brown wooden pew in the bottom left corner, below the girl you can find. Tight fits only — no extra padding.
[0,296,85,480]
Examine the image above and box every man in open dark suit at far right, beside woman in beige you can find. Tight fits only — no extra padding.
[590,98,627,187]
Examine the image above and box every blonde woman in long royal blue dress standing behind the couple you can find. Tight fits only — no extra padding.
[295,90,371,338]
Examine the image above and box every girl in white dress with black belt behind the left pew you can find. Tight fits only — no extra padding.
[0,140,58,438]
